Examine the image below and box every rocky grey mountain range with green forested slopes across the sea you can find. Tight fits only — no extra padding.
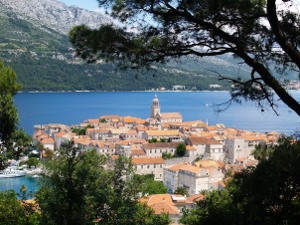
[0,0,284,91]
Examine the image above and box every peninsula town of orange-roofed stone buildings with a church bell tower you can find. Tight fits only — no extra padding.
[33,96,279,223]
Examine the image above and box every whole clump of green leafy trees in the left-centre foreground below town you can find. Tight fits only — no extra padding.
[36,142,169,225]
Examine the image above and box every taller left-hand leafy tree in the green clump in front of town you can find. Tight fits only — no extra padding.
[36,142,103,225]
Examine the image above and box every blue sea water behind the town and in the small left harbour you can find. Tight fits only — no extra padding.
[0,91,300,192]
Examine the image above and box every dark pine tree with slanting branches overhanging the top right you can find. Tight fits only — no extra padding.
[69,0,300,115]
